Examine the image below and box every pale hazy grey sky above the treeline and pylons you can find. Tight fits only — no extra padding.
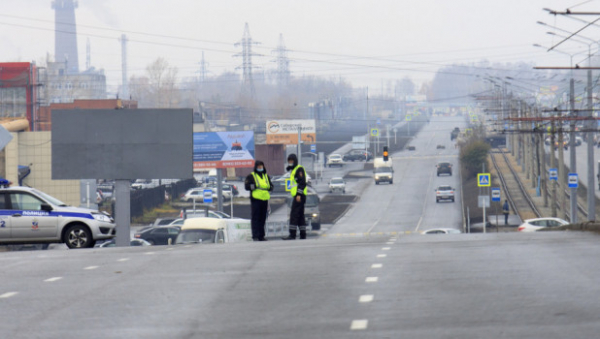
[0,0,600,95]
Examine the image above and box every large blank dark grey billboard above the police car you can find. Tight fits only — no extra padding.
[52,109,193,180]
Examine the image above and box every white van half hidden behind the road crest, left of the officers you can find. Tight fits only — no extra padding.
[175,218,252,244]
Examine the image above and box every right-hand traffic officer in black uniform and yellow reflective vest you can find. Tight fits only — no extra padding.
[283,154,308,240]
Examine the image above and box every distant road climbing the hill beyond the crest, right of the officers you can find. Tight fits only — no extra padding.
[329,117,465,234]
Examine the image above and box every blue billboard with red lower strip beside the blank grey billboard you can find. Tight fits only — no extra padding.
[194,131,254,170]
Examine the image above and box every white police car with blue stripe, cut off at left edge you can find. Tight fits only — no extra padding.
[0,187,115,248]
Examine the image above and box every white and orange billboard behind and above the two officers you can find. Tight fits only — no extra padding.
[267,120,317,145]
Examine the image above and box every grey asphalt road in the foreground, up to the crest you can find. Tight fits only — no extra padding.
[0,232,600,339]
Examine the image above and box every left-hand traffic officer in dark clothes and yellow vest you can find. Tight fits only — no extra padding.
[244,160,273,241]
